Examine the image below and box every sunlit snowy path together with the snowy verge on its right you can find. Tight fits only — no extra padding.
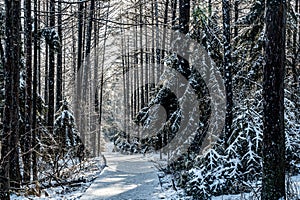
[80,142,191,200]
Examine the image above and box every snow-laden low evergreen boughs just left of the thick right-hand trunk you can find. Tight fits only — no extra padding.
[186,92,262,199]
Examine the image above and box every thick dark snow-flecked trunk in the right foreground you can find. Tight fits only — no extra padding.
[261,0,286,200]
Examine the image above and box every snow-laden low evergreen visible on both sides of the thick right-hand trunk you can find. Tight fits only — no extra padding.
[179,86,300,199]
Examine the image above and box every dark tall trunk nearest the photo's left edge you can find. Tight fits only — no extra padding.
[0,0,22,200]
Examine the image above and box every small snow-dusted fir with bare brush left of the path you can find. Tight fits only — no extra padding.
[35,101,86,187]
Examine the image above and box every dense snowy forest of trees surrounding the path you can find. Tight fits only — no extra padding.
[0,0,300,200]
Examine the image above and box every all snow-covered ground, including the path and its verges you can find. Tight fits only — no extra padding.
[11,143,300,200]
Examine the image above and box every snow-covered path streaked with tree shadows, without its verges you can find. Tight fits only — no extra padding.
[80,152,160,200]
